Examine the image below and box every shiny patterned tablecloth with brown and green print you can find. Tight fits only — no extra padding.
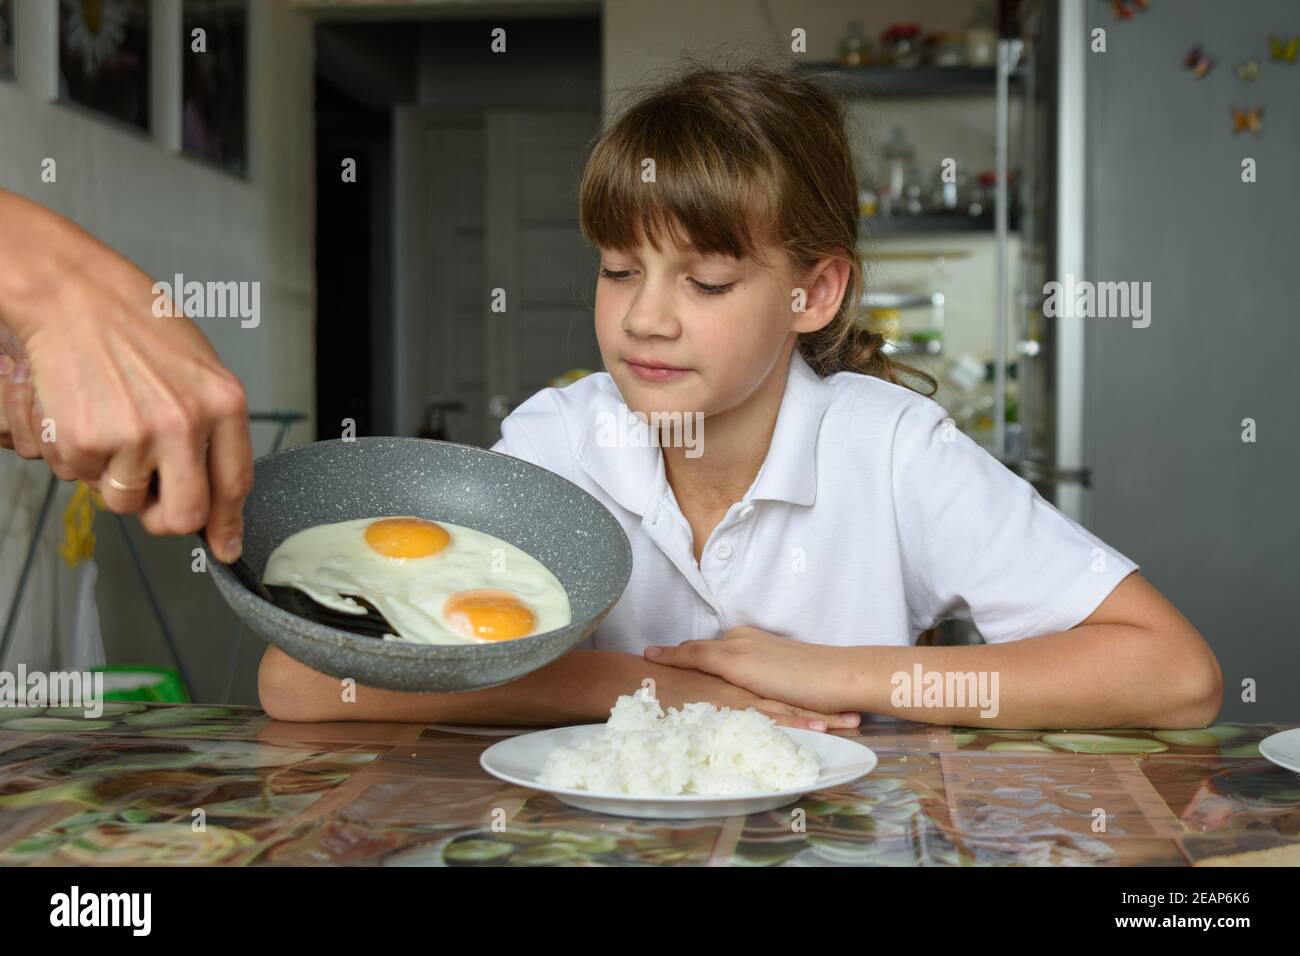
[0,704,1300,866]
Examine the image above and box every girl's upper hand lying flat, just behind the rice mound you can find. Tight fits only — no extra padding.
[645,627,862,727]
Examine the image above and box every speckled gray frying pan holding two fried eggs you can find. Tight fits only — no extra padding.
[208,438,632,692]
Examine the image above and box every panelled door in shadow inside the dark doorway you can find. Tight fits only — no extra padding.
[394,108,601,446]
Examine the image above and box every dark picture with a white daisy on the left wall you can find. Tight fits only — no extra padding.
[59,0,150,131]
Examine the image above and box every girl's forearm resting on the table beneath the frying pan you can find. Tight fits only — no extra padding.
[257,648,646,726]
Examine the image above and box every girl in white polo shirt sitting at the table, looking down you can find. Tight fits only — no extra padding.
[260,68,1222,730]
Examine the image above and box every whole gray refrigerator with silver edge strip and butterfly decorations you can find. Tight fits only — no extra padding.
[1024,0,1300,721]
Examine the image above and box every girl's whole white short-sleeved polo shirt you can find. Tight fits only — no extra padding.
[493,349,1138,654]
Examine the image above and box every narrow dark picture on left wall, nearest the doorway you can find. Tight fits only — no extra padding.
[181,0,248,177]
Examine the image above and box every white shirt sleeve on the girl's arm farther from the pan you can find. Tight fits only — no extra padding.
[892,401,1138,644]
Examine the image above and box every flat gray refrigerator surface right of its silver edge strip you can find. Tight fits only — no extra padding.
[1086,0,1300,722]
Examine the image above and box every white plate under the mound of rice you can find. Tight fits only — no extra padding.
[478,723,876,819]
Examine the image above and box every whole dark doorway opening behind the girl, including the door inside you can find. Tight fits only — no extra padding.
[316,8,602,445]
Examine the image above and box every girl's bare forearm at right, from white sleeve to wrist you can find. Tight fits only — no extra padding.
[836,623,1222,728]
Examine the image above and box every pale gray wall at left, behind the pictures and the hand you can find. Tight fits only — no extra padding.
[0,0,316,704]
